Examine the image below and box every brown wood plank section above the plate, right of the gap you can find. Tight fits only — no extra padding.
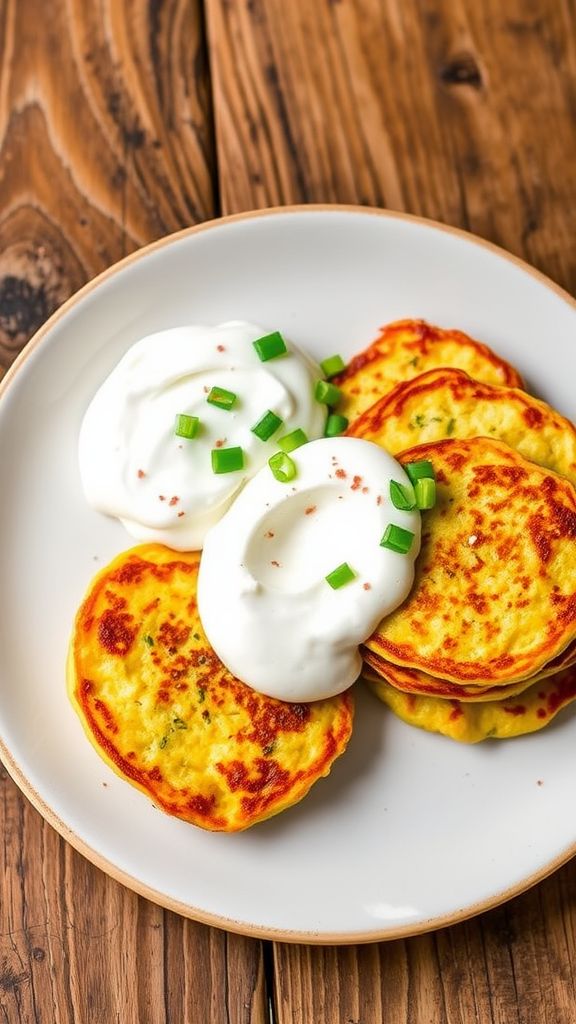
[206,0,576,291]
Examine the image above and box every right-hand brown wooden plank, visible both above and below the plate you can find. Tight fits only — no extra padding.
[207,0,576,1024]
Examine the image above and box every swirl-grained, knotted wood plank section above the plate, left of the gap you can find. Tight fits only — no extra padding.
[0,0,215,373]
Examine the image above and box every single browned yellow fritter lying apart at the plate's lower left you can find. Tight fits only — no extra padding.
[69,544,354,831]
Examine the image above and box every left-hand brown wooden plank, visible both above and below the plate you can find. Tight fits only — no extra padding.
[0,0,266,1024]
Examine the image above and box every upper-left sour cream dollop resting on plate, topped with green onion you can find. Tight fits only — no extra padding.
[79,321,326,551]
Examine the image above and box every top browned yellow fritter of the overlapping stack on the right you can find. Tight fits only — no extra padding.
[367,438,576,686]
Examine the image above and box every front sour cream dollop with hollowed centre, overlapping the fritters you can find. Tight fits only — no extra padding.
[198,437,420,701]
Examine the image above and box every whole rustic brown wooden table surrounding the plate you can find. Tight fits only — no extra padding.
[0,0,576,1024]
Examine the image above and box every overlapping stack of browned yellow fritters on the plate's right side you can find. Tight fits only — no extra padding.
[339,321,576,742]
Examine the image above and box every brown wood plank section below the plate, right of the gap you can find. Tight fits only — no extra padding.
[275,864,576,1024]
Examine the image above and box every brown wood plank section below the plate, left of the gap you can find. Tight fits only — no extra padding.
[0,768,266,1024]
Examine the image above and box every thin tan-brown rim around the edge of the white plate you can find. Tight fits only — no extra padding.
[0,203,576,945]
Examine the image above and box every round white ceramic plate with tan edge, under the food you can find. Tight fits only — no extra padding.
[0,207,576,942]
